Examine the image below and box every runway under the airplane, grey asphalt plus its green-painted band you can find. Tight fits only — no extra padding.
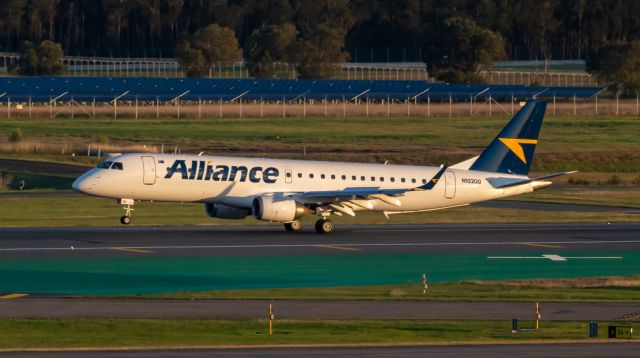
[0,223,640,295]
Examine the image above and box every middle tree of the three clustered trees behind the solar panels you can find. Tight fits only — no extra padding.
[245,23,297,78]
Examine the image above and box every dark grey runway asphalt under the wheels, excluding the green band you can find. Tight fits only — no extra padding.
[0,223,640,259]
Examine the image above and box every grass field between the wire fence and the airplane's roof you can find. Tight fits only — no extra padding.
[0,115,640,172]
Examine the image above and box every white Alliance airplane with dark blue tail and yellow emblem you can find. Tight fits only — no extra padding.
[72,100,575,234]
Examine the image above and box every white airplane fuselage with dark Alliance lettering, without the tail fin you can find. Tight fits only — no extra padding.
[74,153,535,213]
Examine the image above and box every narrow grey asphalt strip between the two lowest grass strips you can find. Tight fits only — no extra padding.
[0,298,640,321]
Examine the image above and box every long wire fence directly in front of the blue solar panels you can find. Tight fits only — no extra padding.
[0,96,640,119]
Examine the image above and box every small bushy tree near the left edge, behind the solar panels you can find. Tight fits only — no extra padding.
[18,41,65,76]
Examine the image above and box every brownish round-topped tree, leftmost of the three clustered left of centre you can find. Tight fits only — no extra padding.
[176,24,242,77]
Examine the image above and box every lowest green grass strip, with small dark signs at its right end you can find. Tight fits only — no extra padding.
[0,319,638,349]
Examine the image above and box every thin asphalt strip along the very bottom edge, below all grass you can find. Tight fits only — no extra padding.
[7,342,640,358]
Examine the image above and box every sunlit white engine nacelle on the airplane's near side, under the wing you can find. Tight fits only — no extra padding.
[251,195,313,223]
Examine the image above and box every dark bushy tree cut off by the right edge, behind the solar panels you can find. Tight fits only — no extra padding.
[587,40,640,95]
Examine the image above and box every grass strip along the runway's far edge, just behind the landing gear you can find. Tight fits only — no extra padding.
[0,192,638,227]
